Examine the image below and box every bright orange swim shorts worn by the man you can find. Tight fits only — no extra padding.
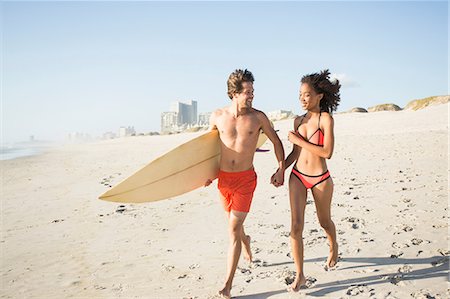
[218,169,257,213]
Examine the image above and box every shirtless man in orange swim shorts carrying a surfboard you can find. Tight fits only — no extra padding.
[205,70,285,298]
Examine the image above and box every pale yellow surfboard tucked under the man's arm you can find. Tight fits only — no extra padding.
[99,130,267,203]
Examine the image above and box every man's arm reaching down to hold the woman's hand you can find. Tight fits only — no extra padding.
[258,111,285,187]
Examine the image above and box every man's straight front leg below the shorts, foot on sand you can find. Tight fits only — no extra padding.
[219,210,247,298]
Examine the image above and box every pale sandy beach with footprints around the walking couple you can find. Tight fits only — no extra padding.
[0,104,450,299]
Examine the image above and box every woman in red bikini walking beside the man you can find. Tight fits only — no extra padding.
[285,70,341,291]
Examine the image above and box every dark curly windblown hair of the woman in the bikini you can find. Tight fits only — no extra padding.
[301,70,341,113]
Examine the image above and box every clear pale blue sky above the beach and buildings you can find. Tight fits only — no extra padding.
[0,1,449,142]
